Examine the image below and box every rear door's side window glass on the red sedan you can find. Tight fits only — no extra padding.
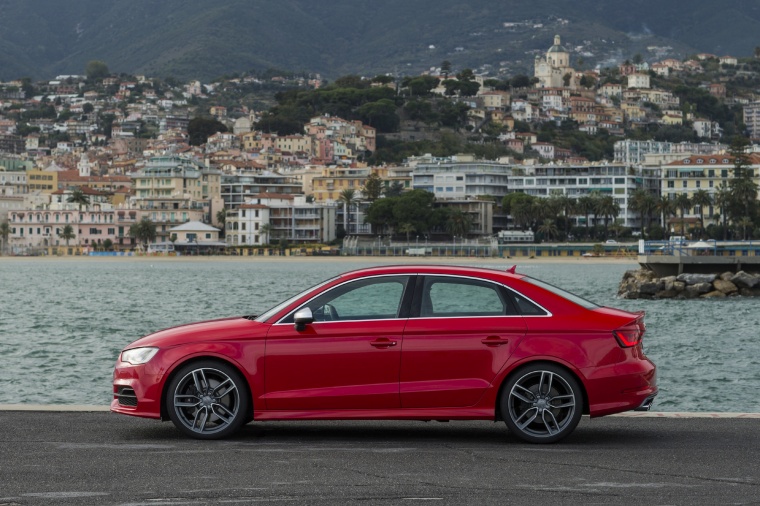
[420,276,513,318]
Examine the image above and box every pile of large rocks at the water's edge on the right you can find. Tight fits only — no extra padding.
[618,269,760,299]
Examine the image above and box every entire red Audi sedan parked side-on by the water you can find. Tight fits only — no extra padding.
[111,265,657,443]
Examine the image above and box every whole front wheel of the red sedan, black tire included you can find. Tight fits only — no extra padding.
[166,360,251,439]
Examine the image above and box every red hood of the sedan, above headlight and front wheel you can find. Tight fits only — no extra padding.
[124,316,269,349]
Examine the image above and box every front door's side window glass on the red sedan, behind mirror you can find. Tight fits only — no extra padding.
[283,276,409,323]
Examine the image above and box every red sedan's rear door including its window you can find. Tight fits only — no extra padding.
[400,276,526,408]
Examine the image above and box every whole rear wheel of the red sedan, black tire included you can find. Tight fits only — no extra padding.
[500,363,583,443]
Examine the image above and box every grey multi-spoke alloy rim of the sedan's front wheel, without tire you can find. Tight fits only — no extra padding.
[173,367,241,435]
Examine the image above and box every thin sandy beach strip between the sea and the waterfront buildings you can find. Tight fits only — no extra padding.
[0,255,638,266]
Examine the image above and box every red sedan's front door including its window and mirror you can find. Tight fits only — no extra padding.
[264,276,413,410]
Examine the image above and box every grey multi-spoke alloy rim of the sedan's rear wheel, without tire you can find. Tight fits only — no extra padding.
[507,369,579,440]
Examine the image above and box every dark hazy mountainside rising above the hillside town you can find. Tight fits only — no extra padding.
[0,0,760,80]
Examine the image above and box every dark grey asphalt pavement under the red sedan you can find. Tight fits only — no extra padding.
[0,411,760,506]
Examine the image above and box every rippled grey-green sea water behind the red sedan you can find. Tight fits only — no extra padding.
[0,257,760,412]
